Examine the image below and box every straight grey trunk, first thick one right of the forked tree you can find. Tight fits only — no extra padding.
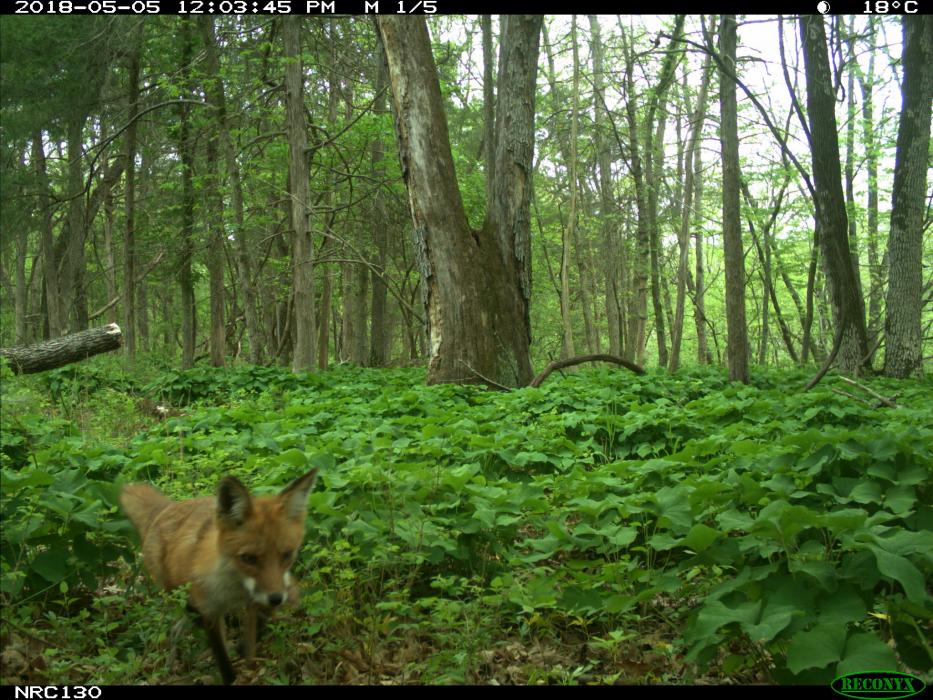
[719,15,749,384]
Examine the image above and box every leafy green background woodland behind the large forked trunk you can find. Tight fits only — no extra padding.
[0,15,933,383]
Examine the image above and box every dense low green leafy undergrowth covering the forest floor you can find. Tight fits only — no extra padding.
[0,361,933,683]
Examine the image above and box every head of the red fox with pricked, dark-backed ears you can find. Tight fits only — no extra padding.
[217,469,317,607]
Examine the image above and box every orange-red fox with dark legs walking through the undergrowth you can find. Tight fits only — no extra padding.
[120,469,317,684]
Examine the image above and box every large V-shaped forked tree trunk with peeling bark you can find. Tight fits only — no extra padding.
[376,15,542,387]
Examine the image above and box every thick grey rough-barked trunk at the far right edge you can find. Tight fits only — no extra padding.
[884,15,933,378]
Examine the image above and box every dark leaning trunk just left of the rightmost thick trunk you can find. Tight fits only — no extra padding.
[800,15,870,374]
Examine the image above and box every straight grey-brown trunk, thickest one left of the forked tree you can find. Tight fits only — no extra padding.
[282,16,317,372]
